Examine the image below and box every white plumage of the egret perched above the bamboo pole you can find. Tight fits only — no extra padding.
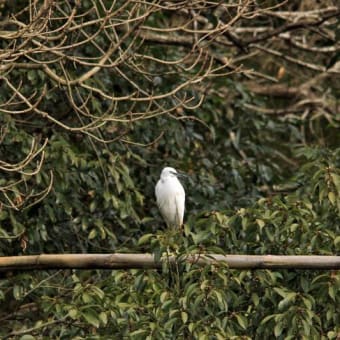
[155,167,185,228]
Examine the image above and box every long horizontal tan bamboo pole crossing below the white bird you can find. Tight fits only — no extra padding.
[0,254,340,272]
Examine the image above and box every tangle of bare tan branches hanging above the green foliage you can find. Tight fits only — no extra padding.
[0,0,340,209]
